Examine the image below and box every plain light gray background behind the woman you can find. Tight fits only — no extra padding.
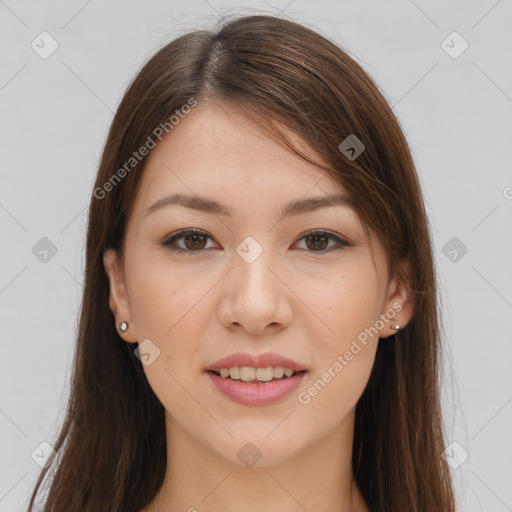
[0,0,512,512]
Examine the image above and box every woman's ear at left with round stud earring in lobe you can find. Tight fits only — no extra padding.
[103,248,137,343]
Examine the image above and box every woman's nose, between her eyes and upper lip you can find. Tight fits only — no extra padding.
[218,251,293,334]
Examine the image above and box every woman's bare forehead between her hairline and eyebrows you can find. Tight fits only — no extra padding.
[130,104,346,215]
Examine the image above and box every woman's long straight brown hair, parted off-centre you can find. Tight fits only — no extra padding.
[28,15,455,512]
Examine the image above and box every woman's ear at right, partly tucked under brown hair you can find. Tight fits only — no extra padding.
[379,260,415,338]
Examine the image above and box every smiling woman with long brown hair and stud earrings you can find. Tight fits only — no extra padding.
[29,12,455,512]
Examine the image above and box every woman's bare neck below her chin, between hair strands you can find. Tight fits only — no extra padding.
[150,411,368,512]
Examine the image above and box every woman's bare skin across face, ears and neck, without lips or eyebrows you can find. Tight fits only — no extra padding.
[104,104,413,512]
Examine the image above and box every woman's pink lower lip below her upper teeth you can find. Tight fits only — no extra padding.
[206,371,307,405]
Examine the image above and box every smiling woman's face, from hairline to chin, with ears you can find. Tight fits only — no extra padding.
[104,104,412,465]
